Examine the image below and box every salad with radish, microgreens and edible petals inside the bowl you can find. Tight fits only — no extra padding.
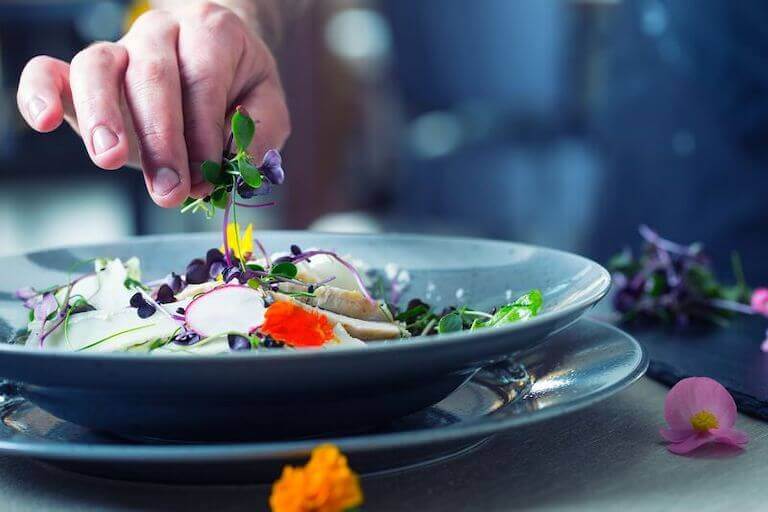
[16,240,542,355]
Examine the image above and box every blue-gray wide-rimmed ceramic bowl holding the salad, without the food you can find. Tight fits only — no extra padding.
[0,232,610,440]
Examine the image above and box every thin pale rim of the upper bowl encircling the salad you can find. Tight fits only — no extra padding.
[0,230,611,365]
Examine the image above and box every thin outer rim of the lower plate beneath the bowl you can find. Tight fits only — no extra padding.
[0,319,648,463]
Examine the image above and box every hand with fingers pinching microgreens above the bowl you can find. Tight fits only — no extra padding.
[17,2,290,207]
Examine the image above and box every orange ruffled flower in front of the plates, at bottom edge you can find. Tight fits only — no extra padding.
[269,444,363,512]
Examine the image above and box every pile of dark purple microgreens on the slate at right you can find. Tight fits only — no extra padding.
[608,226,750,326]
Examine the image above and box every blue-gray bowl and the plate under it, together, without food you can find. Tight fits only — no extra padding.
[0,232,647,484]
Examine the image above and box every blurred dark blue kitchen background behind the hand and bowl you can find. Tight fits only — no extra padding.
[0,0,768,284]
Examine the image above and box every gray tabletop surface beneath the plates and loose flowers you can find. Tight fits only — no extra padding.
[0,378,768,512]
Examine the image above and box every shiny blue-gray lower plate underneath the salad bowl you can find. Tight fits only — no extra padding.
[0,319,647,483]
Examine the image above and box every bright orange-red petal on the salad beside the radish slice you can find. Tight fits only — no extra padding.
[259,301,333,347]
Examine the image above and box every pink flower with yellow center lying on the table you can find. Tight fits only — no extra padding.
[659,377,749,454]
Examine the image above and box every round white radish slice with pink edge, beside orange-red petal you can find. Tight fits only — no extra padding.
[186,285,265,337]
